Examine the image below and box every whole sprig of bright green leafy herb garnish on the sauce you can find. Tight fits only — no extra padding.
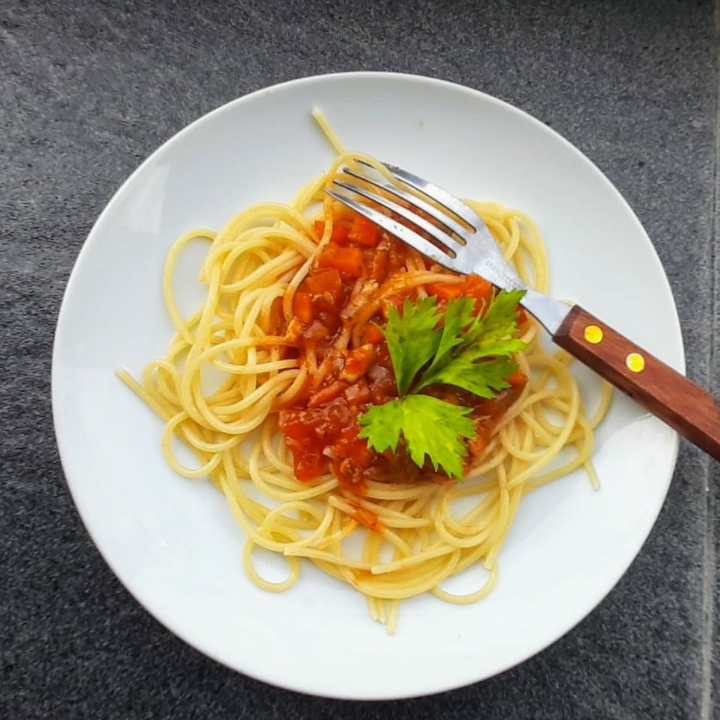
[358,290,526,477]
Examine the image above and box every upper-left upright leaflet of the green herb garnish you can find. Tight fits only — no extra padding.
[384,297,441,396]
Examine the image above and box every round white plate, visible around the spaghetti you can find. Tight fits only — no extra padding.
[53,73,684,699]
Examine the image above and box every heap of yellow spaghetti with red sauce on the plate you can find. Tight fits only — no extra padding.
[118,145,610,632]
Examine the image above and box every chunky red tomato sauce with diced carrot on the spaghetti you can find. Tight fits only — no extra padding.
[279,211,527,490]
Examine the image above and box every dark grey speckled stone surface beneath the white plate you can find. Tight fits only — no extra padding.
[0,0,720,720]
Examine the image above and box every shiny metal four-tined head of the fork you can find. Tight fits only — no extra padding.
[327,160,527,290]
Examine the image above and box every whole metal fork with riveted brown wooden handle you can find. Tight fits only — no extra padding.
[327,160,720,460]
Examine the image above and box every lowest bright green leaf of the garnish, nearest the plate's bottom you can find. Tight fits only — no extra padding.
[358,395,475,477]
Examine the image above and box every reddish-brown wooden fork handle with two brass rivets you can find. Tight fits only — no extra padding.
[553,305,720,460]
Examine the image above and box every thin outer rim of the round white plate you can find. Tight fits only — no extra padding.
[51,71,686,700]
